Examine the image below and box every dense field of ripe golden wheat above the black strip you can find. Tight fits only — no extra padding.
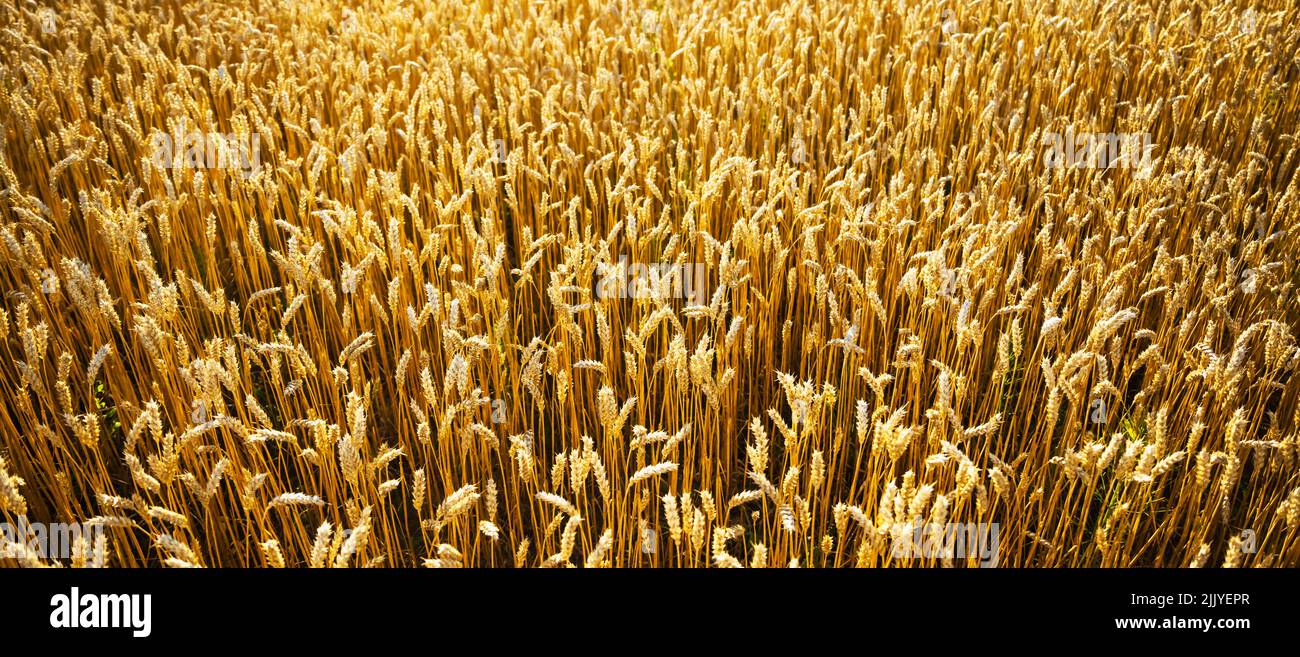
[0,0,1300,567]
